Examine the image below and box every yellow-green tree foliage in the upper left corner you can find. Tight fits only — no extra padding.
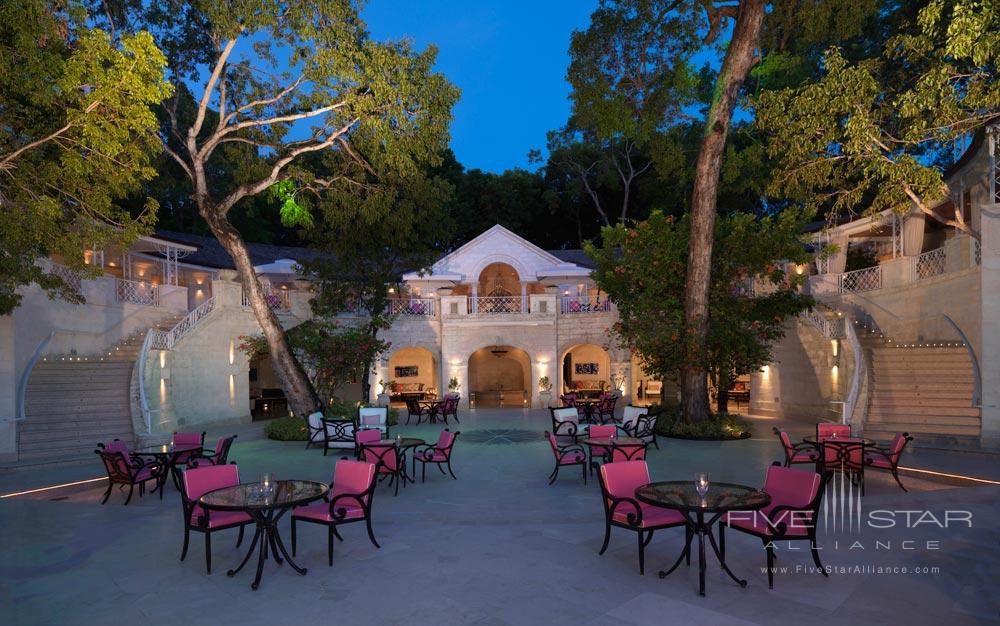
[0,0,171,315]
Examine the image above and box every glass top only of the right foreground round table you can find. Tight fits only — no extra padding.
[635,480,771,513]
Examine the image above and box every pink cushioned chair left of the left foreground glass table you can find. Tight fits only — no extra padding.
[181,464,254,574]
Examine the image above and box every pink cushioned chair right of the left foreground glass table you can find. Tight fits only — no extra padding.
[292,459,382,567]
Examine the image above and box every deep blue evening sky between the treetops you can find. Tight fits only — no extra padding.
[362,0,597,172]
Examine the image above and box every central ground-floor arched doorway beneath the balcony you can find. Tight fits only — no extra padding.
[469,345,531,408]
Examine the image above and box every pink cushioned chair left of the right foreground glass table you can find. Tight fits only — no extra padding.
[598,461,687,574]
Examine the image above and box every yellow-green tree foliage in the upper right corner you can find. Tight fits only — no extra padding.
[755,0,1000,232]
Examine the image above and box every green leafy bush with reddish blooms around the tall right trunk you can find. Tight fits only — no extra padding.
[586,210,812,408]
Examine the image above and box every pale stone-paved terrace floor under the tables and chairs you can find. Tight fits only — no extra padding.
[0,409,1000,626]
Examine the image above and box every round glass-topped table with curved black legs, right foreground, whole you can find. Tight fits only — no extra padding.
[635,480,771,596]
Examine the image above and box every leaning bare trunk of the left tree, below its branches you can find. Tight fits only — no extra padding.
[200,207,322,419]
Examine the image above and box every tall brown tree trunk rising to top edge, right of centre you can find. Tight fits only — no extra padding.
[681,0,764,421]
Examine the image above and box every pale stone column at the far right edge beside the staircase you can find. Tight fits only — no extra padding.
[973,204,1000,447]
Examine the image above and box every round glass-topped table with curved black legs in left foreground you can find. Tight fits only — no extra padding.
[198,480,330,590]
